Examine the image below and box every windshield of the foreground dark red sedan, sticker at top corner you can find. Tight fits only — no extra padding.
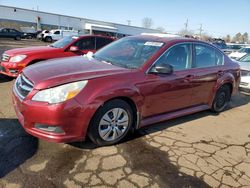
[93,37,164,69]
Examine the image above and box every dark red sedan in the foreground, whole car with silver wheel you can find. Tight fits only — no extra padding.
[13,35,240,146]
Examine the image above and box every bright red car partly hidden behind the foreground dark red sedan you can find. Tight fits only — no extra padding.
[0,35,114,77]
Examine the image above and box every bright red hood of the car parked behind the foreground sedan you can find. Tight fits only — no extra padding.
[5,46,62,56]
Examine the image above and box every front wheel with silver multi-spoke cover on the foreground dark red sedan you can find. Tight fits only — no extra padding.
[88,99,134,146]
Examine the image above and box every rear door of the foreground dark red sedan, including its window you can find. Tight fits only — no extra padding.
[189,43,224,105]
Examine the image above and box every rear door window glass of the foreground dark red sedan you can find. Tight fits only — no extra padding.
[193,44,224,68]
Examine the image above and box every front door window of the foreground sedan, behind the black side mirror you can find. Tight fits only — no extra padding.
[156,44,192,71]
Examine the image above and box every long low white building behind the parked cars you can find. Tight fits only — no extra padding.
[0,5,160,37]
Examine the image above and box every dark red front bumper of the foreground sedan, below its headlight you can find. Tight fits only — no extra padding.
[12,90,93,143]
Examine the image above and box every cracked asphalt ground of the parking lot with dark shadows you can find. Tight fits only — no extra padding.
[0,40,250,188]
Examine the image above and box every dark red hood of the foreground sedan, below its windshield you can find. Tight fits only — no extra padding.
[23,56,131,89]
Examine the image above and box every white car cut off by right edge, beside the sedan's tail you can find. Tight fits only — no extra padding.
[238,54,250,93]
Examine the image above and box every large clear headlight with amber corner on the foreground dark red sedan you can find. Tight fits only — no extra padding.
[32,80,88,104]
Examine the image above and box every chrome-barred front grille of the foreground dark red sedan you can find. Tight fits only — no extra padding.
[14,74,34,99]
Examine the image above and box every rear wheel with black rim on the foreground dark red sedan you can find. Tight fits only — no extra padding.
[212,85,231,113]
